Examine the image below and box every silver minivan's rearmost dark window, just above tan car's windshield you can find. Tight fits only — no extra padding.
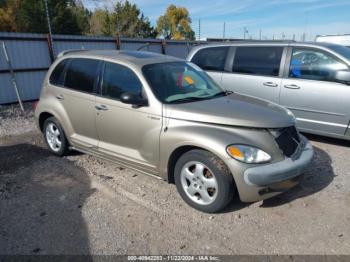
[191,46,229,71]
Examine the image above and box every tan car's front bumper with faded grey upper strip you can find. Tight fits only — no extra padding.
[228,136,314,202]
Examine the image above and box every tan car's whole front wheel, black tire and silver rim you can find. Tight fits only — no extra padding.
[174,149,235,213]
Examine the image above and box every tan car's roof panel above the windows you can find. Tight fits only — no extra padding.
[59,50,184,67]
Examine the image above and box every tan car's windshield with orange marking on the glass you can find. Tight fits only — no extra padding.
[142,62,226,103]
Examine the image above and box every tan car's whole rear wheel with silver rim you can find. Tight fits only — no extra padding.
[43,117,69,156]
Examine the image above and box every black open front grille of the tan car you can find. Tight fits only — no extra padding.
[275,126,300,157]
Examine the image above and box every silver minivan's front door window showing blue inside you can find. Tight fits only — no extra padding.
[289,48,348,81]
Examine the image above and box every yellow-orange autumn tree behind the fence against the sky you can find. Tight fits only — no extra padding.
[157,5,195,40]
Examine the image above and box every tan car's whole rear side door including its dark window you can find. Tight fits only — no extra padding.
[50,58,100,148]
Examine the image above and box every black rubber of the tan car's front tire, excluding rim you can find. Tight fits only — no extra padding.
[174,149,235,213]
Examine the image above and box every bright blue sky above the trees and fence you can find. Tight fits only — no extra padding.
[83,0,350,40]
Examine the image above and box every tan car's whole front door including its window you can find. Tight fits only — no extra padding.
[96,62,162,173]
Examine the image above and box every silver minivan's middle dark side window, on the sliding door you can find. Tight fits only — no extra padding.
[232,47,283,76]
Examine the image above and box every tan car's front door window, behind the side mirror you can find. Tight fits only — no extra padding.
[102,63,142,99]
